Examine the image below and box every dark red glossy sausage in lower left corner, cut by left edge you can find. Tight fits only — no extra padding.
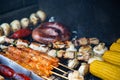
[0,64,15,78]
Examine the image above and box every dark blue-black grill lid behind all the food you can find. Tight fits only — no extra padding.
[0,0,120,45]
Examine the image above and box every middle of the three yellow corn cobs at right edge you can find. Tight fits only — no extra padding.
[102,51,120,66]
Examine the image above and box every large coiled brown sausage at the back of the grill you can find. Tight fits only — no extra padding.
[32,22,70,44]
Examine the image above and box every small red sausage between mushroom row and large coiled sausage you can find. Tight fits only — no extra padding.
[11,28,32,39]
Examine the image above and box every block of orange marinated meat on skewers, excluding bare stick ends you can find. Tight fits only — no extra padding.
[5,46,59,76]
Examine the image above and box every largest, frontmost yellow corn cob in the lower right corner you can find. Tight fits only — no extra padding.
[90,60,120,80]
